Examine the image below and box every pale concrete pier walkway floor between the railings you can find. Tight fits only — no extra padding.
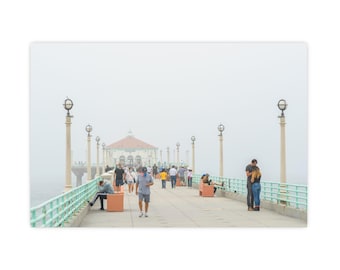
[79,179,307,228]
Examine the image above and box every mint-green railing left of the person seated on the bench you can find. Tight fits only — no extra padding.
[30,178,101,227]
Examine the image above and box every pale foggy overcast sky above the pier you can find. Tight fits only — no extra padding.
[30,42,308,188]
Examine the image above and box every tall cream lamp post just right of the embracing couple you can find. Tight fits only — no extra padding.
[277,99,288,204]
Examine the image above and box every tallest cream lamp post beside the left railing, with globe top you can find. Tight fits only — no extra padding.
[64,97,73,192]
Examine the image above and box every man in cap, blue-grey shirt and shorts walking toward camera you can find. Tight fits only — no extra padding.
[136,167,153,217]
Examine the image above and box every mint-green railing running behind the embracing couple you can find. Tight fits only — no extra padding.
[192,174,308,209]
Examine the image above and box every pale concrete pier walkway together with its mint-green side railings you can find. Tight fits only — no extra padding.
[31,175,307,228]
